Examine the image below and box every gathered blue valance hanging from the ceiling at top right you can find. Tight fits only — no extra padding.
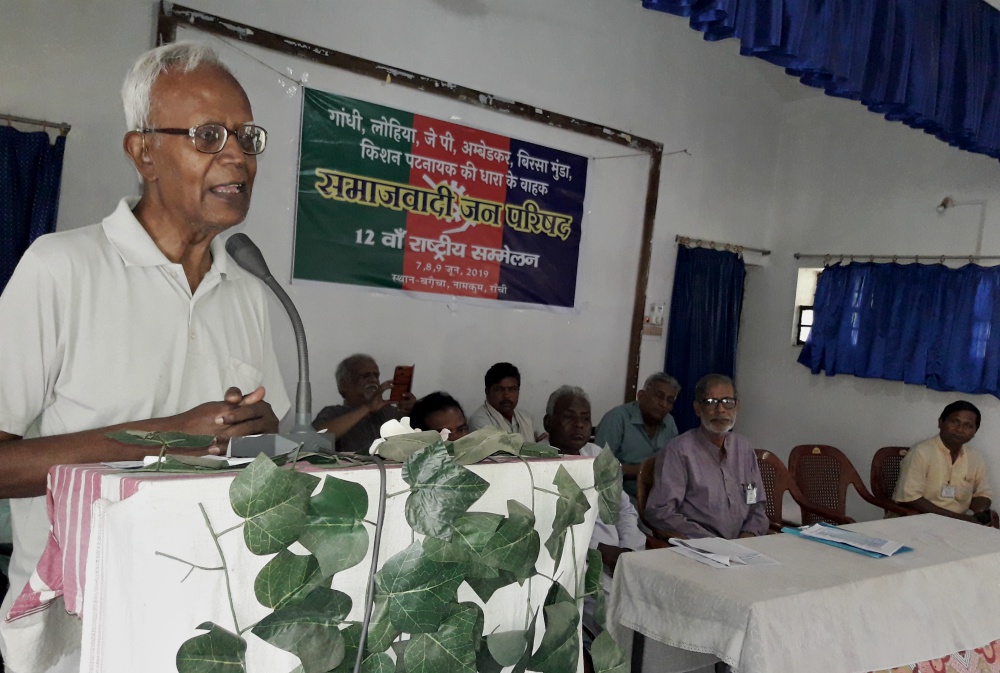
[643,0,1000,158]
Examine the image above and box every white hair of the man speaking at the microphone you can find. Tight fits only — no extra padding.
[122,41,233,131]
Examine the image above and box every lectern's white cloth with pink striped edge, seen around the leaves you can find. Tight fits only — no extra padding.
[3,456,597,673]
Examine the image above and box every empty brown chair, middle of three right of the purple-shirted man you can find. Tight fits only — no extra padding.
[788,444,910,524]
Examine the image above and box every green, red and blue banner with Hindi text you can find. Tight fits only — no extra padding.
[293,89,587,307]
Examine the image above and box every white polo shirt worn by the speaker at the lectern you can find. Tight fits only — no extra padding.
[0,199,289,615]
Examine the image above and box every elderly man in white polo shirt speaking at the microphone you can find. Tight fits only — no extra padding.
[0,42,289,673]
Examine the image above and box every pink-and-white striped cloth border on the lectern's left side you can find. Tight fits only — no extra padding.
[6,465,216,622]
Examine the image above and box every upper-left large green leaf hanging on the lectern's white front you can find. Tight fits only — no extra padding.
[229,455,319,555]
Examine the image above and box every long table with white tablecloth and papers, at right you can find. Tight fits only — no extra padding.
[608,514,1000,673]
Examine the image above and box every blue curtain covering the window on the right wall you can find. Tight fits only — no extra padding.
[799,263,1000,397]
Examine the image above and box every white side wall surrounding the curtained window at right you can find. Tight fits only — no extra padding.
[737,90,1000,518]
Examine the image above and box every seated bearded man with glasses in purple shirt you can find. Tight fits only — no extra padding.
[646,374,768,539]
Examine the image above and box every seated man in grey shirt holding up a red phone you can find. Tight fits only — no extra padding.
[313,353,414,453]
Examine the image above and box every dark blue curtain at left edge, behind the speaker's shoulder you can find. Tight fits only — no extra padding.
[0,126,66,292]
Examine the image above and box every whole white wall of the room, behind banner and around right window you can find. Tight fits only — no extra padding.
[0,0,1000,517]
